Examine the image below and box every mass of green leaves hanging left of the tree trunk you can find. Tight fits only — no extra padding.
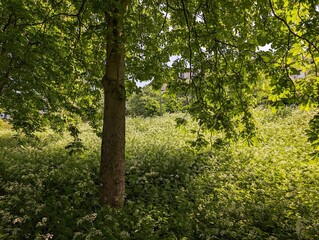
[0,1,104,137]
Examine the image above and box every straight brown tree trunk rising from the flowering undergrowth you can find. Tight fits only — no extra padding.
[99,1,126,207]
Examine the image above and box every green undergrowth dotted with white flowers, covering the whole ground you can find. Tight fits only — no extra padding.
[0,108,319,240]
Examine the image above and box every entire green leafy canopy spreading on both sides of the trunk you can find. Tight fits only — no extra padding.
[0,0,319,144]
